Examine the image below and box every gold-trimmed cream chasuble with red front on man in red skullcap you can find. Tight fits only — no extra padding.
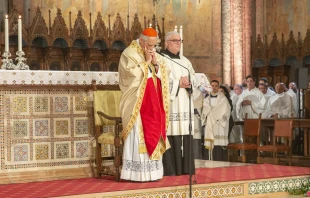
[118,41,169,160]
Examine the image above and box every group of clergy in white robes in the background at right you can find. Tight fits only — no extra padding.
[193,75,303,161]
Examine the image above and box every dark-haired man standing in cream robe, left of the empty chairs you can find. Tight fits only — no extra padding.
[201,80,231,161]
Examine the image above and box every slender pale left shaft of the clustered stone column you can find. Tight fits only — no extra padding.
[222,0,232,85]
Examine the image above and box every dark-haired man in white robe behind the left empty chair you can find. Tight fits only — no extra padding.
[236,75,266,120]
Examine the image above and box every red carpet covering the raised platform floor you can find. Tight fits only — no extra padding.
[0,164,310,198]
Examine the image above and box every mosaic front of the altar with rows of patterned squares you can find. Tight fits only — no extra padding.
[0,89,94,173]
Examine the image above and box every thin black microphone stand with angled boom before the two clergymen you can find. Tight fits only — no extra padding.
[156,51,196,198]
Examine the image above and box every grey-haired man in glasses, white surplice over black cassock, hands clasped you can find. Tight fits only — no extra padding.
[162,31,196,176]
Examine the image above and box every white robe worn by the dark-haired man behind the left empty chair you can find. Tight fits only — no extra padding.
[236,87,266,119]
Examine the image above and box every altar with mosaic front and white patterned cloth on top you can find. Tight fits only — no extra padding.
[0,70,209,184]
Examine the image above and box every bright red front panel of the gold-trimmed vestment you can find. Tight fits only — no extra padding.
[140,78,166,156]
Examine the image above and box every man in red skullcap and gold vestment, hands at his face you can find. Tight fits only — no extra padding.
[118,28,169,182]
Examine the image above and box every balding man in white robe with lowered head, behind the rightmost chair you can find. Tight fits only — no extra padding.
[267,83,294,118]
